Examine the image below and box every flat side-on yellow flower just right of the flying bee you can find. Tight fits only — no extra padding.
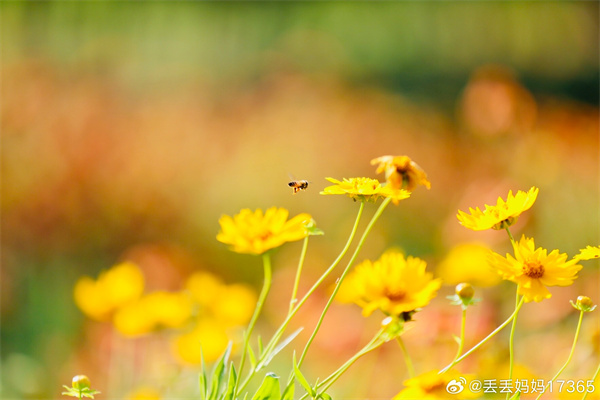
[321,178,410,204]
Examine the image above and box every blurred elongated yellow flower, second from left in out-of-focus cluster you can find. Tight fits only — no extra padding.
[113,291,192,336]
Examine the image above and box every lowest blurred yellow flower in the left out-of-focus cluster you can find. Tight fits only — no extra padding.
[173,319,229,364]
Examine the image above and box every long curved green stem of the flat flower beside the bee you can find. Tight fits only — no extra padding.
[240,203,364,391]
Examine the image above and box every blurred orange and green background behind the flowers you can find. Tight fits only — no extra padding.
[0,1,600,399]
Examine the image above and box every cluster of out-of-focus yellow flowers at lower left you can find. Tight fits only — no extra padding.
[74,262,256,364]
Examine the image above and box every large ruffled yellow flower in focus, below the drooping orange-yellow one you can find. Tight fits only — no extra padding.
[340,251,442,316]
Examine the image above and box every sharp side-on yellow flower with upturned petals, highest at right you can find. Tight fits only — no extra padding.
[456,186,539,231]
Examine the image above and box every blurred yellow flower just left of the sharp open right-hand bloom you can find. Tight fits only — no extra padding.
[437,243,500,287]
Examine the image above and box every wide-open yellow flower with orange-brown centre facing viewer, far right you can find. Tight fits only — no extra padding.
[491,235,581,302]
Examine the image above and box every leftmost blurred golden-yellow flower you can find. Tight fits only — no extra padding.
[74,262,144,321]
